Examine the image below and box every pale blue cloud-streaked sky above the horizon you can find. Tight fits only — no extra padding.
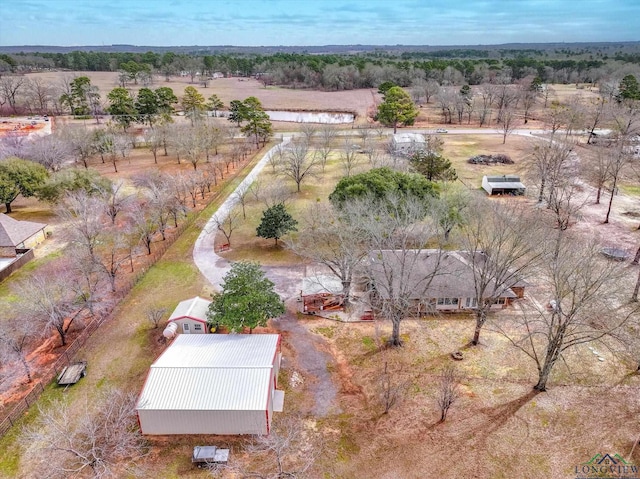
[0,0,640,46]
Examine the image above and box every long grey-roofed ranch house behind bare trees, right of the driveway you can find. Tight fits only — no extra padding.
[369,249,526,315]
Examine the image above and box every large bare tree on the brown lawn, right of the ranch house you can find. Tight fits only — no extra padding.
[493,231,637,391]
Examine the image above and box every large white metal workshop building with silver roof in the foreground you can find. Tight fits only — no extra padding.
[136,334,284,435]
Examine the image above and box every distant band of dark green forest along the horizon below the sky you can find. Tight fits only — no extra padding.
[0,46,640,90]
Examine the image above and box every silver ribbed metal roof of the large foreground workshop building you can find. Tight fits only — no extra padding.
[137,334,280,411]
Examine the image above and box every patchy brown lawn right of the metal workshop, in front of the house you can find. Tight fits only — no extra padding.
[311,315,640,479]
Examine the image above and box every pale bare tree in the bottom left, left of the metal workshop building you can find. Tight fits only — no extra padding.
[21,389,147,479]
